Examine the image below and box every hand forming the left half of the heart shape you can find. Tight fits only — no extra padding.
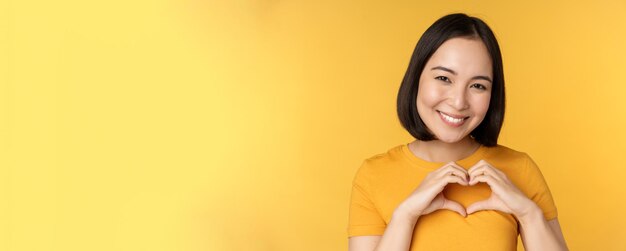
[398,162,469,219]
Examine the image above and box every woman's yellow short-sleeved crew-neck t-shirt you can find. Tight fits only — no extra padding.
[347,145,557,251]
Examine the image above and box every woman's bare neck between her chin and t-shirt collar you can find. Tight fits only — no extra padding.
[409,136,480,163]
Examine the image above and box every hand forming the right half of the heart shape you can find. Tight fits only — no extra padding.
[466,160,538,219]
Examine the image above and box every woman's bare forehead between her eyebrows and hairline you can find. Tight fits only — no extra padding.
[424,37,493,76]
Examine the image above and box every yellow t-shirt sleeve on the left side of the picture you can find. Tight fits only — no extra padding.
[348,160,387,237]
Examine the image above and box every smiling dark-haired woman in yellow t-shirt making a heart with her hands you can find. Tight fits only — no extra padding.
[348,14,567,251]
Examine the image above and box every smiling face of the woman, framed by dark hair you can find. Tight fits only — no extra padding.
[416,38,493,143]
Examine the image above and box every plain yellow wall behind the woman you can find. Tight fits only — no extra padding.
[0,0,626,251]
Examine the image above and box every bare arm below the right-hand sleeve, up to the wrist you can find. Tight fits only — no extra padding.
[519,210,569,251]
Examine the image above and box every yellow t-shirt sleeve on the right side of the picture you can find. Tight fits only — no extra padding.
[526,155,557,220]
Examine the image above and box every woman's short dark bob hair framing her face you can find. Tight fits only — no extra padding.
[397,13,504,146]
